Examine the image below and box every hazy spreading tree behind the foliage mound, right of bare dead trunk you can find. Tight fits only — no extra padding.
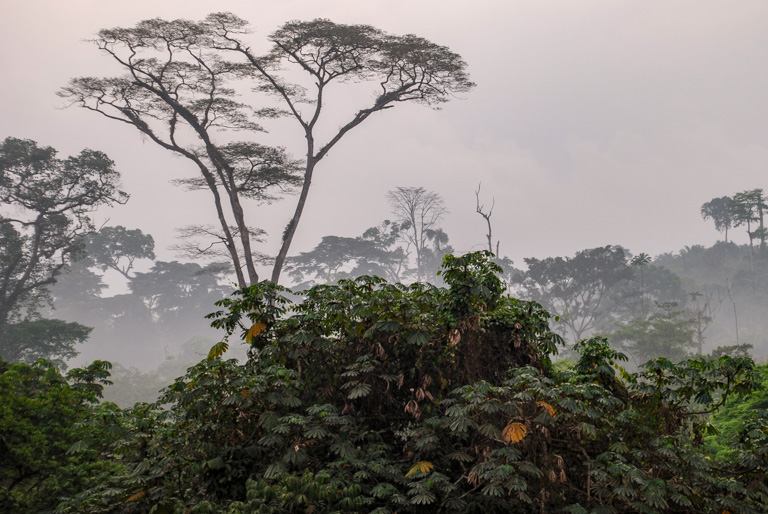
[515,246,632,342]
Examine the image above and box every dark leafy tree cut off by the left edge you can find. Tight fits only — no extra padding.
[0,137,128,328]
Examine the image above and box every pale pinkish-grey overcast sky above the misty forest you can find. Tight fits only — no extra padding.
[0,0,768,282]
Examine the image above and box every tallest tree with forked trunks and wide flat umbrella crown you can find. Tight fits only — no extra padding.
[61,13,474,285]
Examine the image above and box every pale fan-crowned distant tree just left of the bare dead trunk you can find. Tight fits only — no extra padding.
[387,187,448,280]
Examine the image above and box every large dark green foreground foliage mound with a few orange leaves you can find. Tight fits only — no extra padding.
[4,253,768,513]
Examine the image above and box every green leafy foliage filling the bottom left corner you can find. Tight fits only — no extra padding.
[0,359,123,513]
